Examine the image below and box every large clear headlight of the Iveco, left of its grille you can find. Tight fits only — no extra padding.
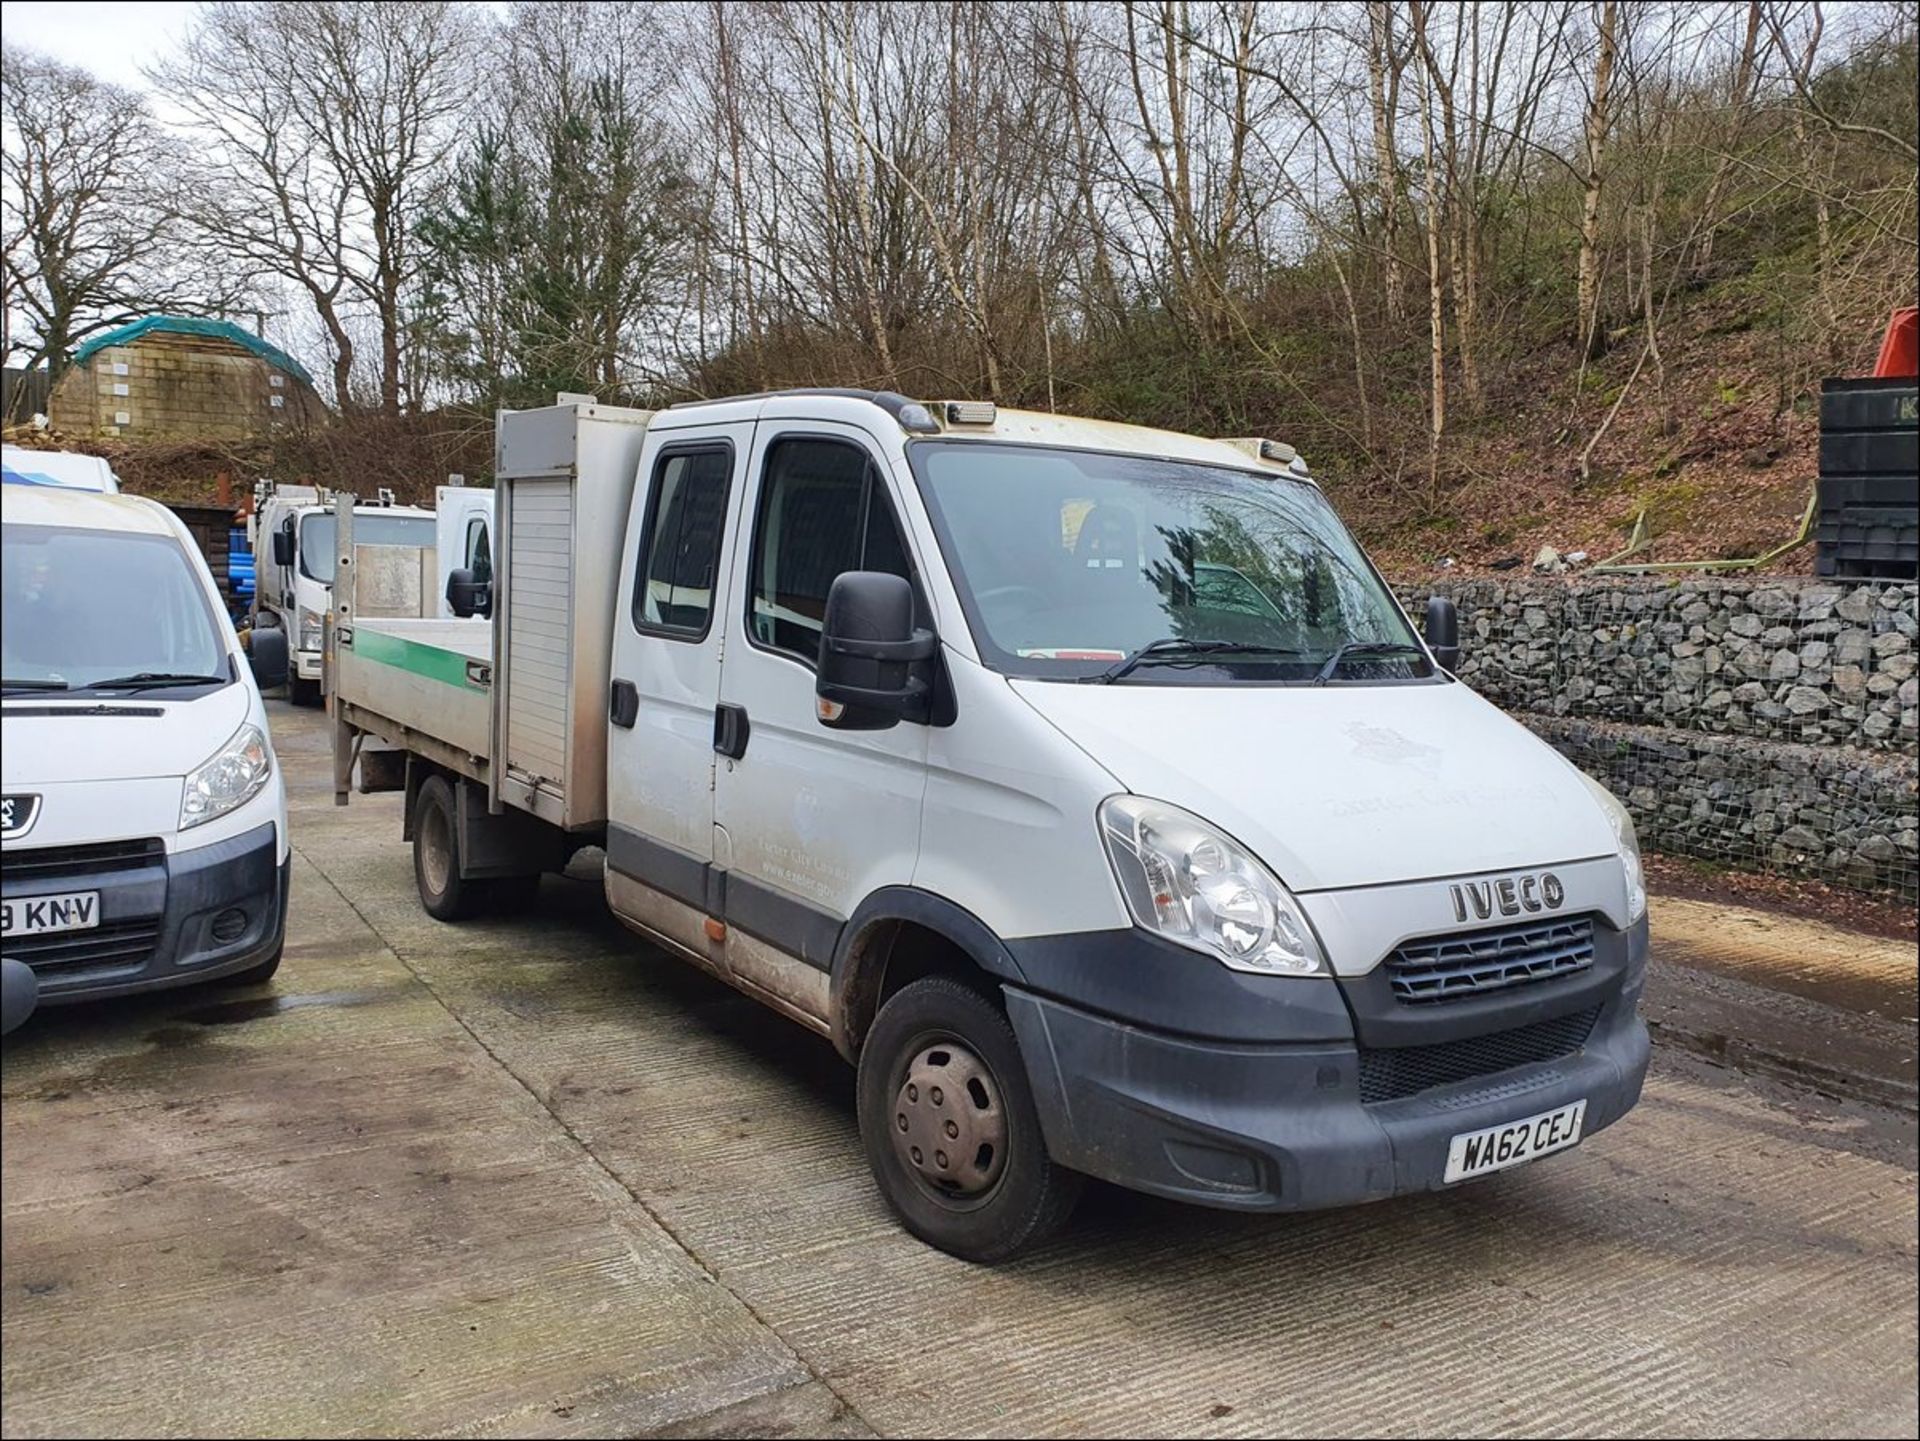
[1100,796,1327,975]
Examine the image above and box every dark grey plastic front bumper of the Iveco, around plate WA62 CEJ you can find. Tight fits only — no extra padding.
[1006,921,1649,1211]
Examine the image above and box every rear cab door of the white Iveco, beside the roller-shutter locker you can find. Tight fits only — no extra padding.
[607,422,753,969]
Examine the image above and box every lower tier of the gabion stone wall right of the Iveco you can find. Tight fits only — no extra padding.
[1523,716,1920,902]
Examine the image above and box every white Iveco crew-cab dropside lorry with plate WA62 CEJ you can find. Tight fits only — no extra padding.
[332,391,1647,1261]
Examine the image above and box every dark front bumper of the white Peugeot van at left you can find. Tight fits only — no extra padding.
[0,821,292,1005]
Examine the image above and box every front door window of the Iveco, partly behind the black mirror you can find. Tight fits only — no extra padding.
[747,439,920,666]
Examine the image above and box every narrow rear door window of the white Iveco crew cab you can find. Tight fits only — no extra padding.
[634,447,733,639]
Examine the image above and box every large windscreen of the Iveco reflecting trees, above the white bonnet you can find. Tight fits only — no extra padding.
[908,441,1434,685]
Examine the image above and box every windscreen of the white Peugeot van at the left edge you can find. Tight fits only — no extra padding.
[0,524,230,691]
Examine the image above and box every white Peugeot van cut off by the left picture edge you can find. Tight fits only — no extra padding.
[0,487,290,1027]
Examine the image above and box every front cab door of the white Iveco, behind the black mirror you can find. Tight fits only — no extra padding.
[712,420,927,1025]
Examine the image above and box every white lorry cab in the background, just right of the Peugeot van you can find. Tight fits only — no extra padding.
[253,485,436,706]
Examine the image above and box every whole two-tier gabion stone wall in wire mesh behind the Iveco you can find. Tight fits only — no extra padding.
[1402,576,1920,902]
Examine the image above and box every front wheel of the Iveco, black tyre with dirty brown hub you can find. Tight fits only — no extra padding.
[858,977,1083,1264]
